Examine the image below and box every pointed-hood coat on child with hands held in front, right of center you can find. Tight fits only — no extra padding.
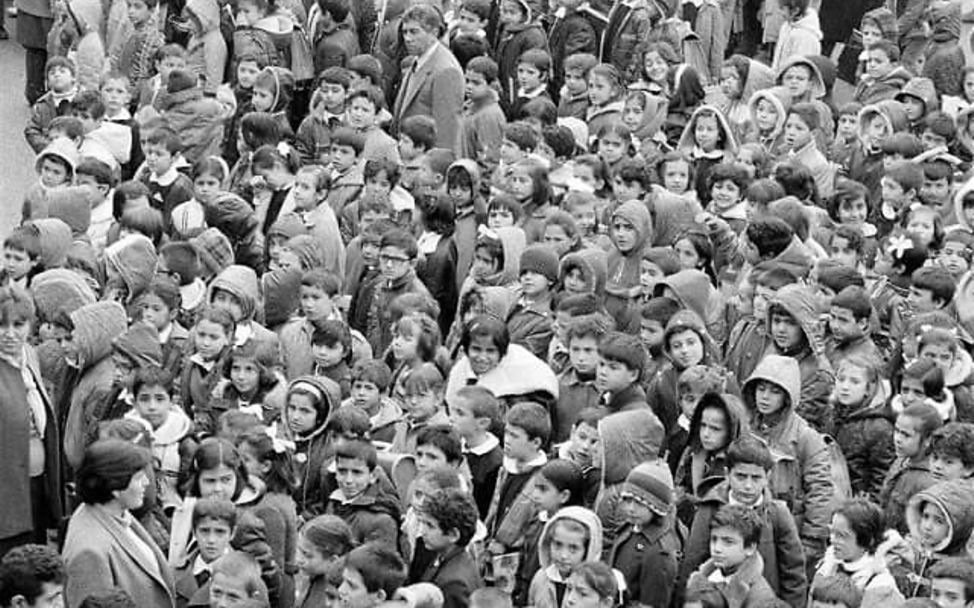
[605,201,653,326]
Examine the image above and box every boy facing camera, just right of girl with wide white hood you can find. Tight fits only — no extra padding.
[551,315,605,443]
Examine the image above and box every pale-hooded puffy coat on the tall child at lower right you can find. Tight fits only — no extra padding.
[742,355,833,556]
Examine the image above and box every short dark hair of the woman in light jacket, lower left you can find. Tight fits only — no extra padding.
[77,439,152,505]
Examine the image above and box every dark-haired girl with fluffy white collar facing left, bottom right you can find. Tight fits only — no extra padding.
[810,498,903,608]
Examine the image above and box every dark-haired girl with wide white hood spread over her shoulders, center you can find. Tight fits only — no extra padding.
[446,316,558,405]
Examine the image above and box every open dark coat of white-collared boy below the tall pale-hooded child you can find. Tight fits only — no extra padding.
[681,480,808,608]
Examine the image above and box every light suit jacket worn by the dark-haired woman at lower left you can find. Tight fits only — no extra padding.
[61,504,176,608]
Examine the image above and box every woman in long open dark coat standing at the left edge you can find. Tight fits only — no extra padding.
[0,287,61,556]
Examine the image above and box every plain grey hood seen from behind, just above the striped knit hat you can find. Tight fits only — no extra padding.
[599,407,664,486]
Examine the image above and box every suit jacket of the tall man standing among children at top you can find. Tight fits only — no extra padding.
[393,42,464,156]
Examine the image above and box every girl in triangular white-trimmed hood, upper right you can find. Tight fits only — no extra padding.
[677,105,737,205]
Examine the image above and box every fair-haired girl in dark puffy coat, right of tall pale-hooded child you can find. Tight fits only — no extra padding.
[831,355,895,501]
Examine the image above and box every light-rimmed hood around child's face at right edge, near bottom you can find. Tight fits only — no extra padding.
[906,479,974,555]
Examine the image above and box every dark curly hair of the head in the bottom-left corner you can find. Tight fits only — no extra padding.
[0,544,67,606]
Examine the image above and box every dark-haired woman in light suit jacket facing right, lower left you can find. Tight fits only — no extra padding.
[62,439,176,608]
